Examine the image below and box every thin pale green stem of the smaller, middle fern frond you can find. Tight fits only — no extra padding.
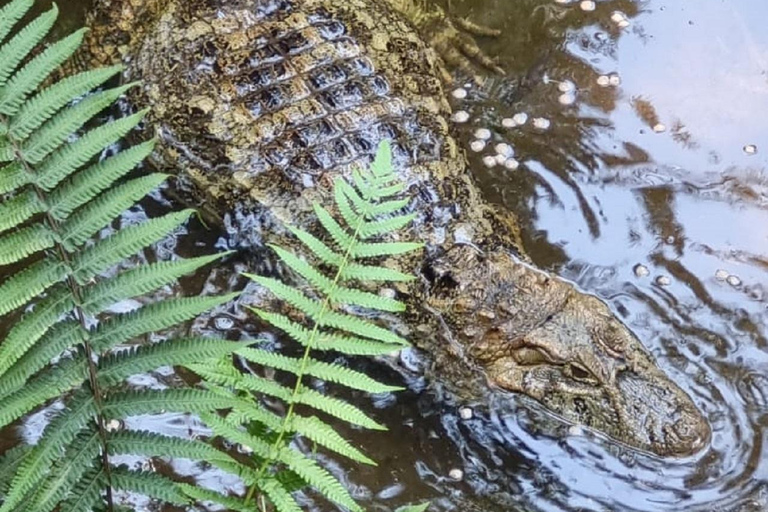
[245,185,371,506]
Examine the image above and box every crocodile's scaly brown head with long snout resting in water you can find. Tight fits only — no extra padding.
[430,246,710,456]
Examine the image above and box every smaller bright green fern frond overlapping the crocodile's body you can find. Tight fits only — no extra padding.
[188,142,421,512]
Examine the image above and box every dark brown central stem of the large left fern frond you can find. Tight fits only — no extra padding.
[0,114,114,512]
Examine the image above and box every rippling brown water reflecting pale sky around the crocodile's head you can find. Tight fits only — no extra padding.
[10,0,768,512]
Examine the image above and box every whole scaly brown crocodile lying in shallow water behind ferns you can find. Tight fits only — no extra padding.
[78,0,710,457]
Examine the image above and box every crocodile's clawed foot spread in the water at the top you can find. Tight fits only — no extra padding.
[389,0,504,84]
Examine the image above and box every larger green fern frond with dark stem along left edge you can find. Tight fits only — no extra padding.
[0,0,250,512]
